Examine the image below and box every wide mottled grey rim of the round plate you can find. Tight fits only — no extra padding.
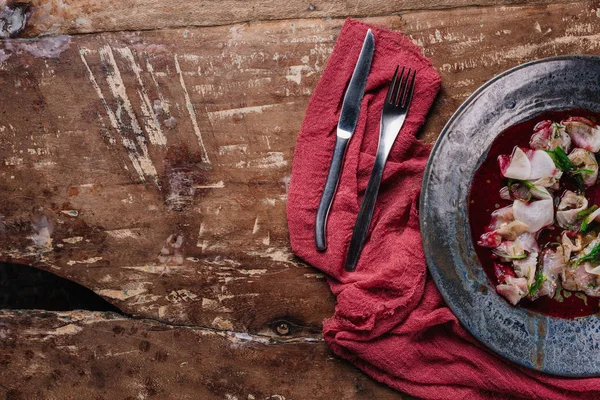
[420,56,600,377]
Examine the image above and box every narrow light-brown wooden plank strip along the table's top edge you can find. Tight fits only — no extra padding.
[9,0,580,37]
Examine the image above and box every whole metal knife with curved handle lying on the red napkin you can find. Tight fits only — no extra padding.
[315,29,375,251]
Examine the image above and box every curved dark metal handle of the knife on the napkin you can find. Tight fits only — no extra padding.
[315,136,349,251]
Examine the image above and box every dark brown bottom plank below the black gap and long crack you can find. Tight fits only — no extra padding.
[0,311,409,400]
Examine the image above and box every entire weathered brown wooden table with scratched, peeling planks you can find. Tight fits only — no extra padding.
[0,0,600,400]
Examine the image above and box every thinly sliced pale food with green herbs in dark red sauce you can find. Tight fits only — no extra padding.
[469,111,600,317]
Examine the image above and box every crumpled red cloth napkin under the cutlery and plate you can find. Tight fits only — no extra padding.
[287,20,600,400]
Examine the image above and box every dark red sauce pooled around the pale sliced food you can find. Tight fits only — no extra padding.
[469,110,600,318]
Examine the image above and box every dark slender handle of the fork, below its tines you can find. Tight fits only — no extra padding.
[346,146,387,272]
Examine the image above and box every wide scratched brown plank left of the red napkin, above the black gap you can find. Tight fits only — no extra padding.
[0,17,408,332]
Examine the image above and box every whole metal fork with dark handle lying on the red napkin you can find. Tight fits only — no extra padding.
[346,66,417,271]
